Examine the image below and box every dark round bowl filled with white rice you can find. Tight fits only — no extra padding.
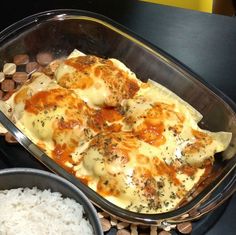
[0,168,103,235]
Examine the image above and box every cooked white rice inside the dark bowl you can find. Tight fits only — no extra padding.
[0,187,94,235]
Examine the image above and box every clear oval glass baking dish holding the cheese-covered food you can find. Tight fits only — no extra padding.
[0,9,236,227]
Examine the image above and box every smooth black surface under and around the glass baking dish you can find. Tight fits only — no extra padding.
[0,0,236,235]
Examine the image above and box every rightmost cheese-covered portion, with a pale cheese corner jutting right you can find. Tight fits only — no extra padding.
[123,90,231,166]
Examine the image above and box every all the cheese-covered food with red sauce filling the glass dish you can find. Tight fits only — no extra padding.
[0,50,231,213]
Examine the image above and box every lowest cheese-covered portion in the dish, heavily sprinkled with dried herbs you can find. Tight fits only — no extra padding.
[75,132,205,213]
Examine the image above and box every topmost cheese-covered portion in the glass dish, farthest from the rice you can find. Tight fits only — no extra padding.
[56,56,139,107]
